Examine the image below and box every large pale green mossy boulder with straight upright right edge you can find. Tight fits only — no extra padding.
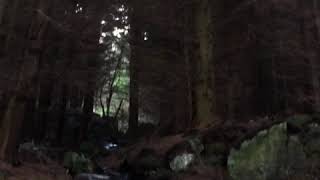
[228,123,287,180]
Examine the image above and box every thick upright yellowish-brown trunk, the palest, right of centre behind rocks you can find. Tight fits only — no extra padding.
[195,0,214,127]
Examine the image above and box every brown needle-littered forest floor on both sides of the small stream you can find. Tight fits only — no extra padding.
[0,114,318,180]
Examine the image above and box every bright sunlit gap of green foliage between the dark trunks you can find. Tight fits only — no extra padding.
[95,4,130,123]
